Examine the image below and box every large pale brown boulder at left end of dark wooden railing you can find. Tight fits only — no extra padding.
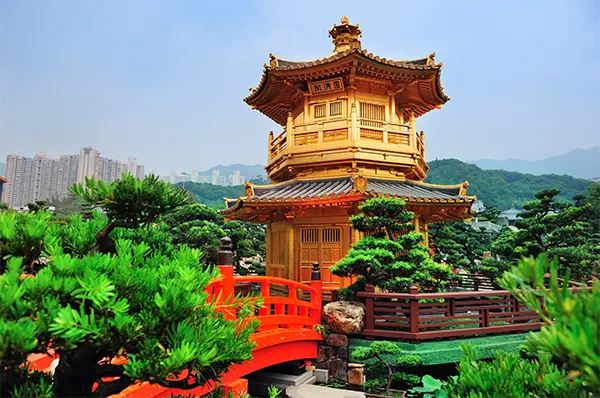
[323,301,365,334]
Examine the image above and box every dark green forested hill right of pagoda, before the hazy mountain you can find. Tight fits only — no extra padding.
[426,159,592,210]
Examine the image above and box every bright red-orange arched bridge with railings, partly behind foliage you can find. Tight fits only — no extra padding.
[30,252,323,398]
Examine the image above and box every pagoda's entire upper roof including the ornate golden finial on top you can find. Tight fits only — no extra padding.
[244,18,450,125]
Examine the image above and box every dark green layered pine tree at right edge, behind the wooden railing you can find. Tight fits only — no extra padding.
[493,189,600,279]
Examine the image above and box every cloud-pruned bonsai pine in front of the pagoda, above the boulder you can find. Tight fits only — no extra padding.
[332,198,453,296]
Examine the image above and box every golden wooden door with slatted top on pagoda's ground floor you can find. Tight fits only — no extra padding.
[298,226,344,292]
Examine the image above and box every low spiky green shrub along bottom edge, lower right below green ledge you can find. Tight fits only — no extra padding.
[444,345,587,398]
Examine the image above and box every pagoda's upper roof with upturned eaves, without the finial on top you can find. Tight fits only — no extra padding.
[244,48,450,125]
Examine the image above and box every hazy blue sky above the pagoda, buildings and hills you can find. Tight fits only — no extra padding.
[0,0,600,174]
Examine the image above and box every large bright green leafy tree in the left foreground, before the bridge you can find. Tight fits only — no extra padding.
[0,180,260,398]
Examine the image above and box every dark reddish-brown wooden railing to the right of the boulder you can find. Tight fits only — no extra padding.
[357,285,578,342]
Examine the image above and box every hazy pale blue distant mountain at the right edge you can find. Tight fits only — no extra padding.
[468,146,600,179]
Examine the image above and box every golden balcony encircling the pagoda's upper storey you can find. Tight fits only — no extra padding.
[267,117,427,181]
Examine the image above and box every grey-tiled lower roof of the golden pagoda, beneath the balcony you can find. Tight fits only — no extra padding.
[221,177,476,216]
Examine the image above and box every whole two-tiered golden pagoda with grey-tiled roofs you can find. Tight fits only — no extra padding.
[222,17,475,298]
